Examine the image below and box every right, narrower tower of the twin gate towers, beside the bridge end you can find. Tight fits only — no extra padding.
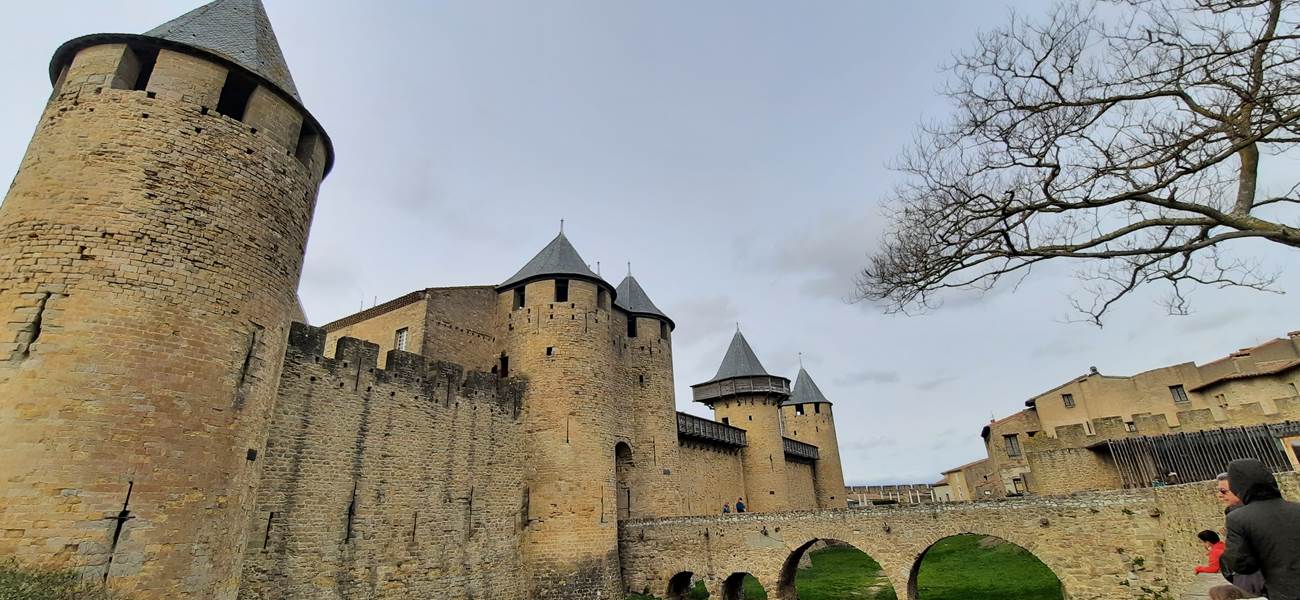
[614,273,683,518]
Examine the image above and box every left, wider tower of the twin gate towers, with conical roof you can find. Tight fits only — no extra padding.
[497,232,624,600]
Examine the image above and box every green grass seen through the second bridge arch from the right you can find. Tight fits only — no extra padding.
[794,545,898,600]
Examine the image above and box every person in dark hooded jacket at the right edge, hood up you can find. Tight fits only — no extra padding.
[1222,458,1300,600]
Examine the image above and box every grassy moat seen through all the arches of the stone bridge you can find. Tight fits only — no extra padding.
[629,535,1062,600]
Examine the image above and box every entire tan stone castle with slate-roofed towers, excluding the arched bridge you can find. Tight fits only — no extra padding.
[0,0,845,599]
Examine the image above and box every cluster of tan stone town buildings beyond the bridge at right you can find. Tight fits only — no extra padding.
[945,331,1300,499]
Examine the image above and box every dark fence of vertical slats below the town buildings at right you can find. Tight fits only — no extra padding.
[1099,422,1300,487]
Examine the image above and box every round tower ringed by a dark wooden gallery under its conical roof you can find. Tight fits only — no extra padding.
[690,330,790,512]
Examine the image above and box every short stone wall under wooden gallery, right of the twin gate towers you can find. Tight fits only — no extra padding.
[679,440,745,514]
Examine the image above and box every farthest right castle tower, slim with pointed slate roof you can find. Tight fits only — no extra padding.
[781,366,848,508]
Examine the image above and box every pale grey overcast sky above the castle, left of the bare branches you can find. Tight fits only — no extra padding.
[0,0,1300,483]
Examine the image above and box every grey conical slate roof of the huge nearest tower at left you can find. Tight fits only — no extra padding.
[144,0,302,101]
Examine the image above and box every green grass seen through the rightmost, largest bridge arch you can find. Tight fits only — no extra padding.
[917,535,1062,600]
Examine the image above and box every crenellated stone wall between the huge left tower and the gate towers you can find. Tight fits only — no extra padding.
[239,323,528,600]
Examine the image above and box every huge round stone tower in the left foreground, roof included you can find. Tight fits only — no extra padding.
[0,0,332,599]
